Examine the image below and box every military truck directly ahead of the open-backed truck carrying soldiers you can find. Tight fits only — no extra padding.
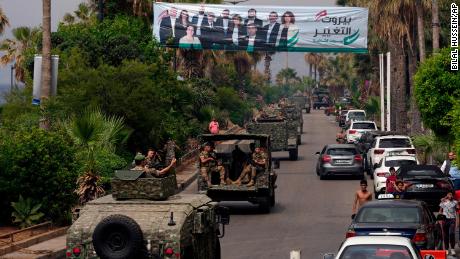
[246,117,299,161]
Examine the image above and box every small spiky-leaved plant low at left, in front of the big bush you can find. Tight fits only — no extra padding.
[11,195,45,231]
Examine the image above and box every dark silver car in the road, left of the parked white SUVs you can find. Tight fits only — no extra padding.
[316,144,364,180]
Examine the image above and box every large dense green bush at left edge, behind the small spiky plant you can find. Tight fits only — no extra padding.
[0,127,77,225]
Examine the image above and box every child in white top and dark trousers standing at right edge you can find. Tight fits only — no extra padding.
[439,191,459,255]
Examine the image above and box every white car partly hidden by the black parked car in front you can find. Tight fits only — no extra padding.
[374,155,419,197]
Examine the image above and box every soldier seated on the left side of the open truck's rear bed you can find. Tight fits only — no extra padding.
[200,143,225,186]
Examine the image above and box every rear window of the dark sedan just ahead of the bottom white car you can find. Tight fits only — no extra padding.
[355,206,420,223]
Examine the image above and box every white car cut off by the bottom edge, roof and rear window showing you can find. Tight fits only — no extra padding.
[323,236,422,259]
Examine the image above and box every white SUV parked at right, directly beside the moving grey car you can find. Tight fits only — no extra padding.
[367,135,415,173]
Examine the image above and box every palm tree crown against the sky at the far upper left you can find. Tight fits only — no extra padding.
[0,27,40,82]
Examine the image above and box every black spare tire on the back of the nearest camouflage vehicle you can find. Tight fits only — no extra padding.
[93,214,145,259]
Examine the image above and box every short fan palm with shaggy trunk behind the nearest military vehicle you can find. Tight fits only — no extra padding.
[64,109,131,204]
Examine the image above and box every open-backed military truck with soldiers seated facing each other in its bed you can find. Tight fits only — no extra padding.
[197,134,279,213]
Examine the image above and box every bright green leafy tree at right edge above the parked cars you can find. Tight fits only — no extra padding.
[414,48,460,135]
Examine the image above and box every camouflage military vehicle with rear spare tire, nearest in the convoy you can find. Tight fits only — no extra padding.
[66,170,229,259]
